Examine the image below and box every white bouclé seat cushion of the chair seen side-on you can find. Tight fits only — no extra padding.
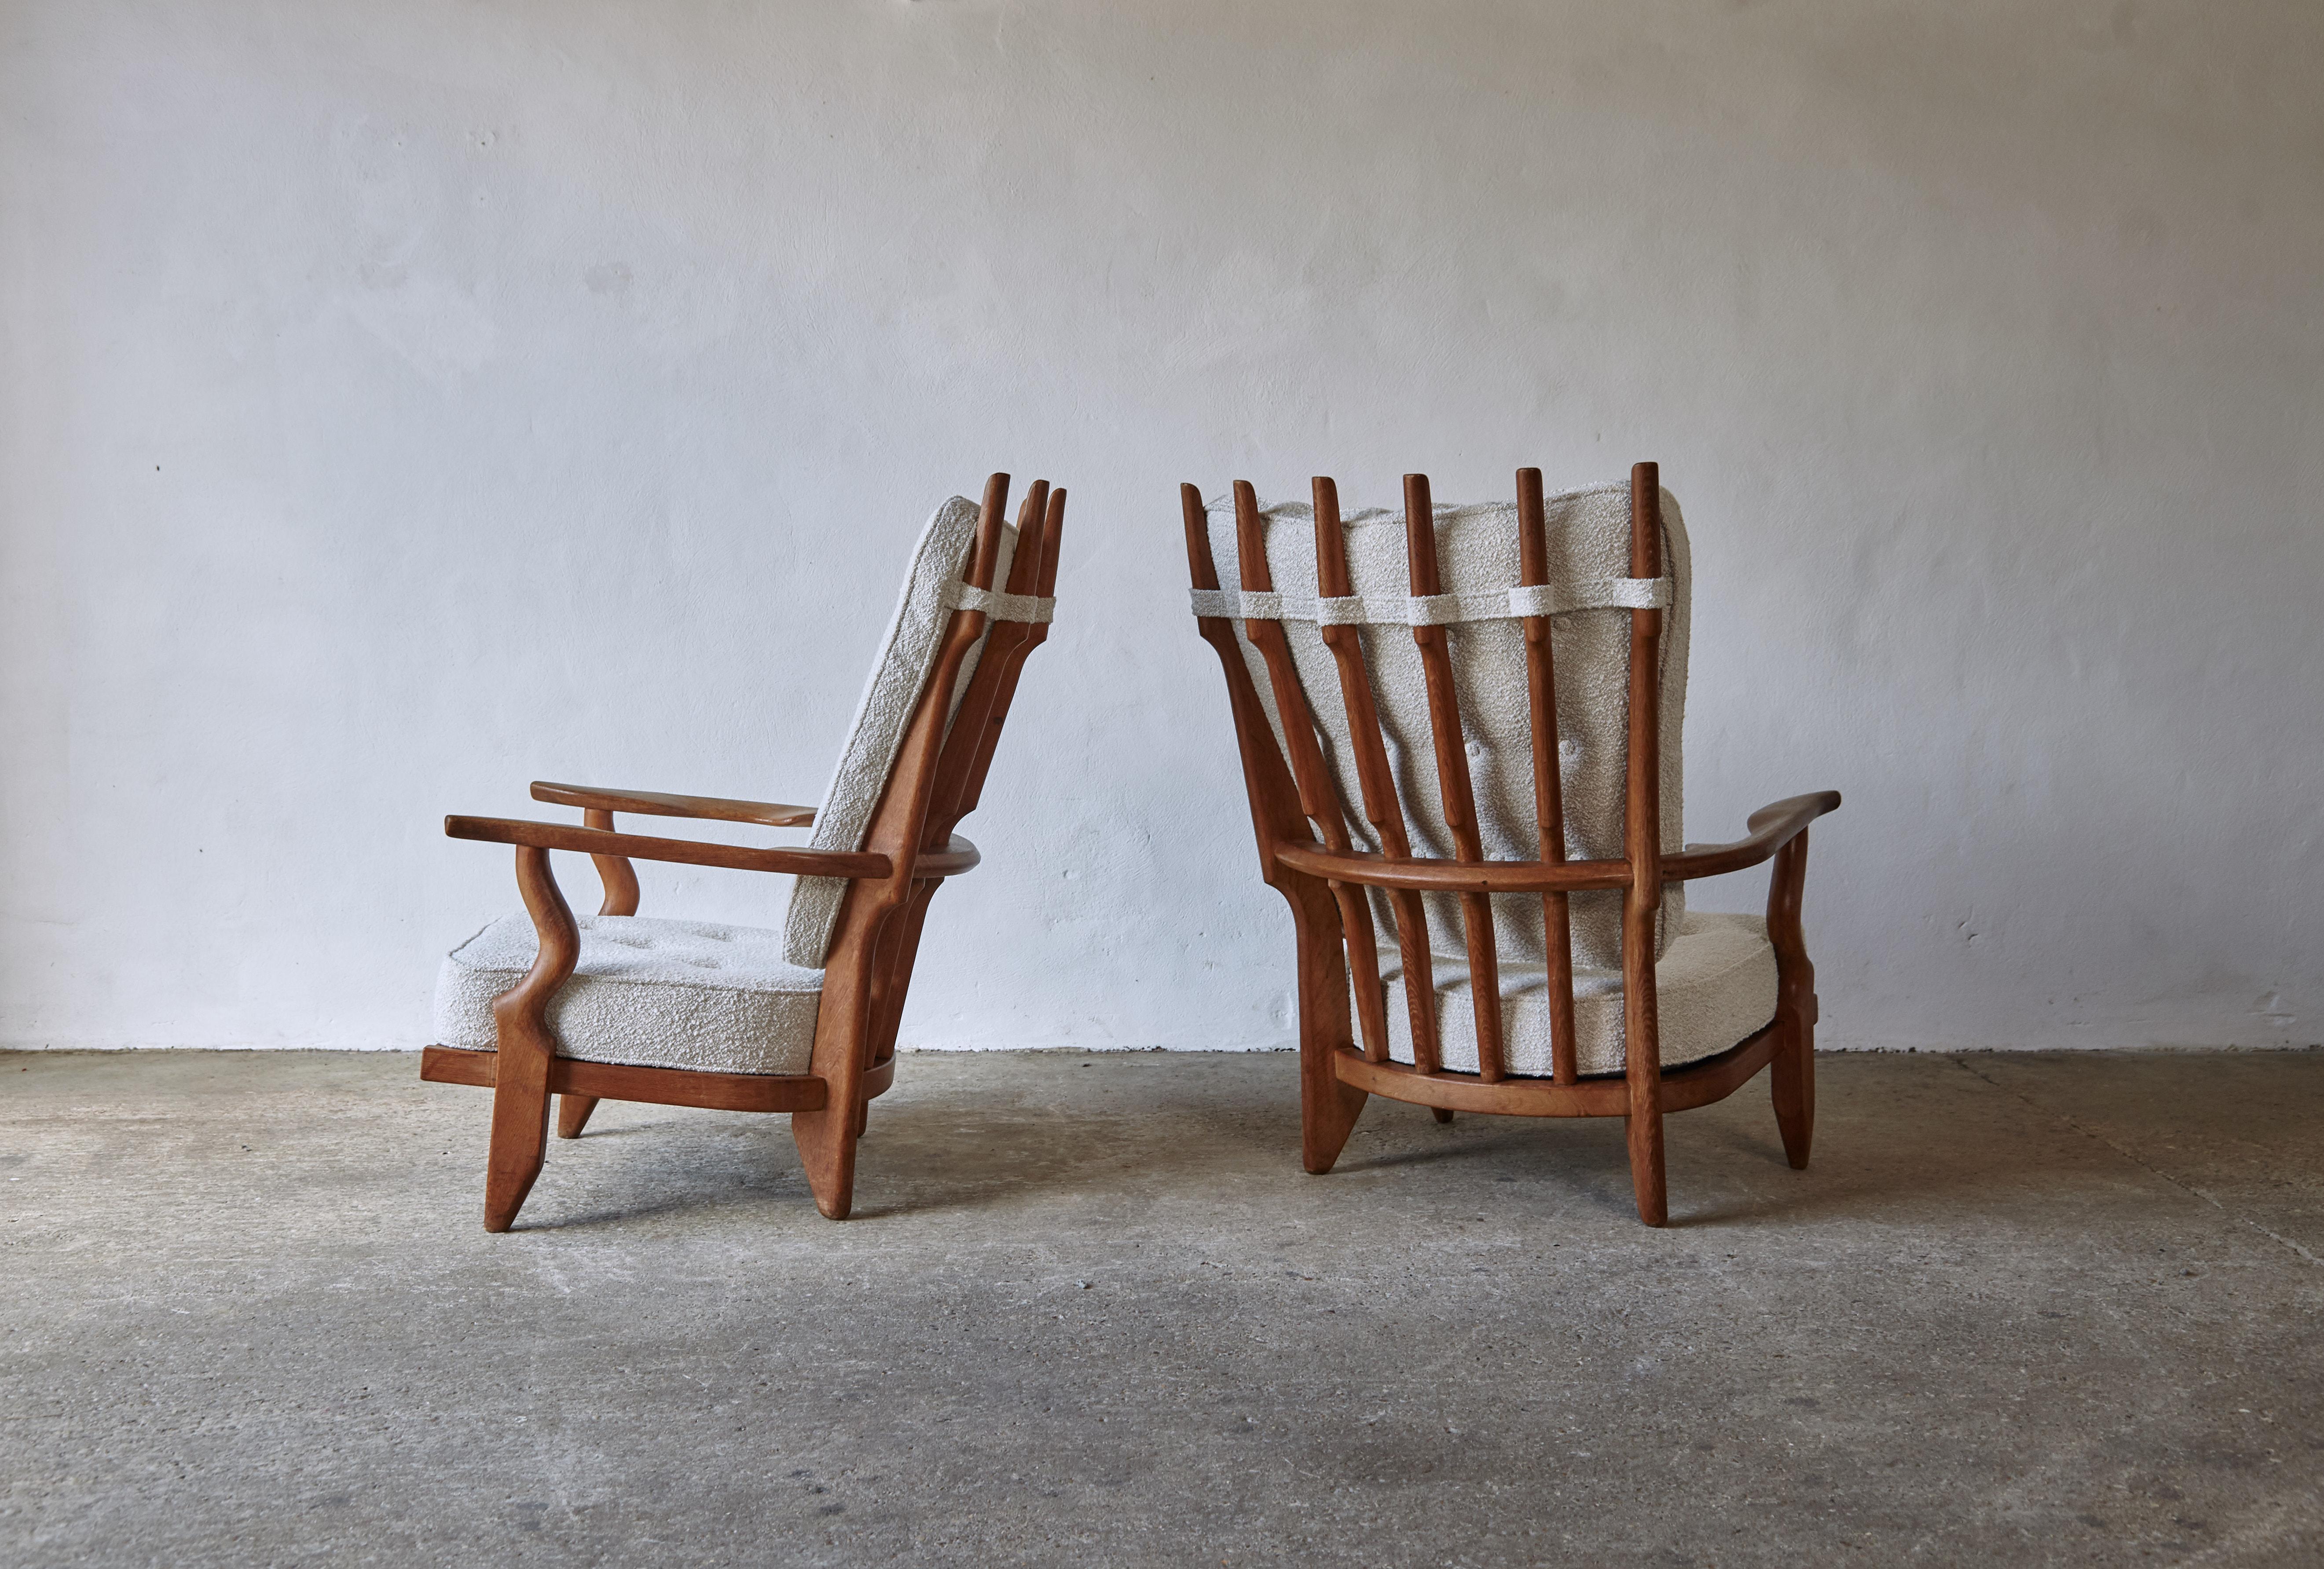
[435,911,823,1074]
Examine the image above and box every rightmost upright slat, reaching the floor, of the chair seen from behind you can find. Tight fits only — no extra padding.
[1622,463,1668,1225]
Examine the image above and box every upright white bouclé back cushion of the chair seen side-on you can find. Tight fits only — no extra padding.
[783,495,1015,969]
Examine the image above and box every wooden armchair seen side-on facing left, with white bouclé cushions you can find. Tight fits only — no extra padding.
[421,474,1064,1232]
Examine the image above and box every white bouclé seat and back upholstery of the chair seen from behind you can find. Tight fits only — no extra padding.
[1195,483,1775,1074]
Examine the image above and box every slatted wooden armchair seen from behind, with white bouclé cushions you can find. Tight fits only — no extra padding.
[1180,463,1840,1225]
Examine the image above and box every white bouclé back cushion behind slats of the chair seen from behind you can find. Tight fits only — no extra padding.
[1206,483,1690,969]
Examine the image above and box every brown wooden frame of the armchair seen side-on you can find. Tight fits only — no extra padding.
[421,474,1064,1232]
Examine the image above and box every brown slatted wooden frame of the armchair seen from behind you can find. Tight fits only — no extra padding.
[1178,463,1840,1225]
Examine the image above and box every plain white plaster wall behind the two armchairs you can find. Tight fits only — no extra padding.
[0,0,2324,1046]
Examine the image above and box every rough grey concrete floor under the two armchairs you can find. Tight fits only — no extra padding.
[0,1053,2324,1567]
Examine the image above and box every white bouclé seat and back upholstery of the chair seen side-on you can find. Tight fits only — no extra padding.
[435,495,1027,1074]
